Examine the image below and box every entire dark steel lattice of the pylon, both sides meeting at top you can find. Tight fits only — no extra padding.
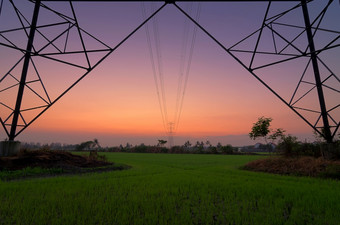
[0,0,340,143]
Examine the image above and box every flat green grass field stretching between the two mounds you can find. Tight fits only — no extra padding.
[0,153,340,225]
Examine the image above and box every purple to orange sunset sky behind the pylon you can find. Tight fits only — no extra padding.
[0,0,340,146]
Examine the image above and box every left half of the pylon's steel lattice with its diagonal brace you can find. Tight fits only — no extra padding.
[0,0,166,140]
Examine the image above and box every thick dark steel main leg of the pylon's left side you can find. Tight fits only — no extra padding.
[9,0,41,141]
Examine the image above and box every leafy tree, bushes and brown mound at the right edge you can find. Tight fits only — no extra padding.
[243,117,340,179]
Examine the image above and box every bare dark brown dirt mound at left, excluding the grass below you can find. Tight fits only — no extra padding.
[0,150,113,170]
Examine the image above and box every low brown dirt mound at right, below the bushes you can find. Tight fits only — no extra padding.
[243,156,340,179]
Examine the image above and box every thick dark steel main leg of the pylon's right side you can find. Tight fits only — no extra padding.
[301,0,333,143]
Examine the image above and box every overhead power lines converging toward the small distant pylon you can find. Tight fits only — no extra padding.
[142,3,201,141]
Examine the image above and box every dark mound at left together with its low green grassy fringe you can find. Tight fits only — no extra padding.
[0,149,127,180]
